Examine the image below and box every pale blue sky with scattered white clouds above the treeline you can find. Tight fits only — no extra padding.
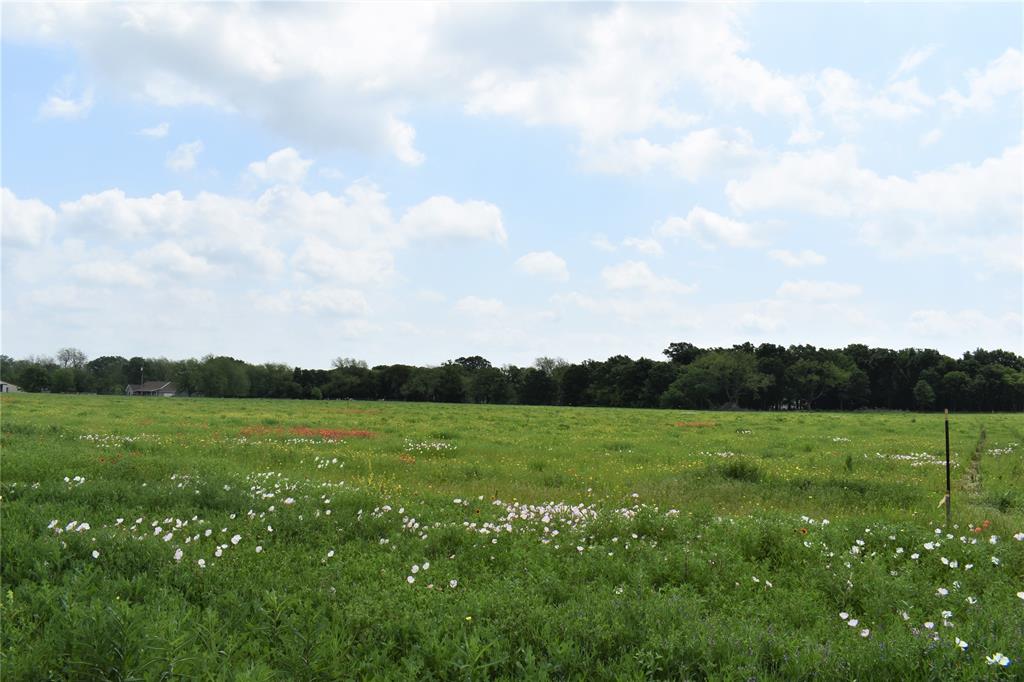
[0,2,1024,368]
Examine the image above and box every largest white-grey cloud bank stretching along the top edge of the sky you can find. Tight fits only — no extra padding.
[4,3,814,158]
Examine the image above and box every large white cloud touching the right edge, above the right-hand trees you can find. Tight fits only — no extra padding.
[726,144,1024,268]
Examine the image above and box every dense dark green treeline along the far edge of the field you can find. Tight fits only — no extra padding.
[0,343,1024,412]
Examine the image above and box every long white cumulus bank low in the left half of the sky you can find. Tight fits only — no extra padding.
[2,176,507,285]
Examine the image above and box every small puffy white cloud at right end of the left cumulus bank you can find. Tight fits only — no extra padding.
[399,197,508,244]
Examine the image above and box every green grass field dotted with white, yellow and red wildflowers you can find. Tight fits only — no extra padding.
[0,394,1024,680]
